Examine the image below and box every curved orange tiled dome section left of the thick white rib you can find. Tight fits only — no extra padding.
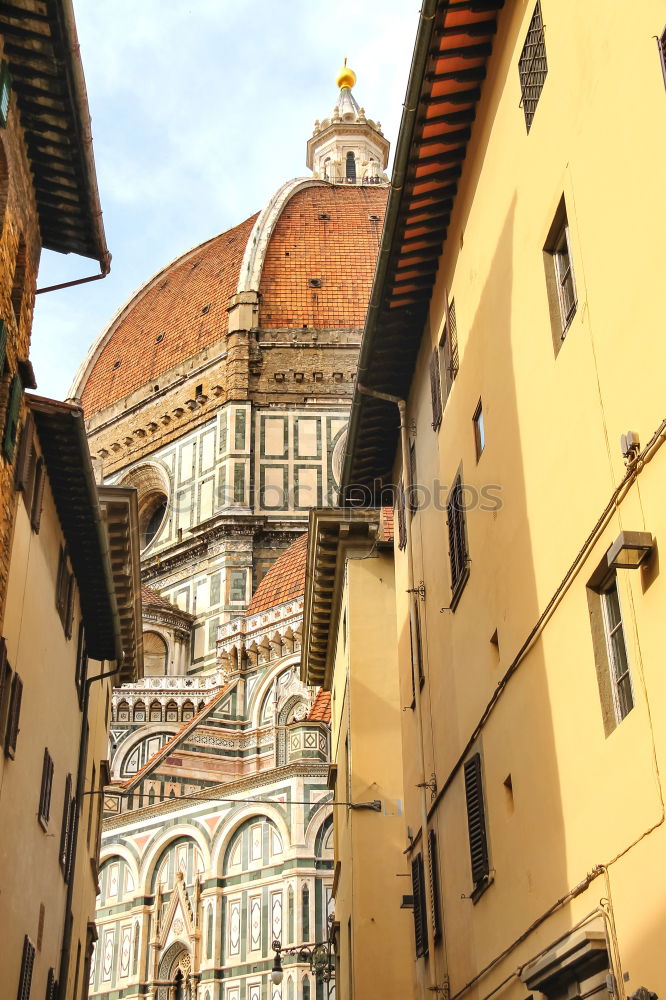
[81,215,256,416]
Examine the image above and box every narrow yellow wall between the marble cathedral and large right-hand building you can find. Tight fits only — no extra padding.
[331,550,412,1000]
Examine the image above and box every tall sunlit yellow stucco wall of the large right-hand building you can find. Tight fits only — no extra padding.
[386,0,666,998]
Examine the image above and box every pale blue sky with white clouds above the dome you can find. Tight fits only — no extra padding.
[31,0,420,398]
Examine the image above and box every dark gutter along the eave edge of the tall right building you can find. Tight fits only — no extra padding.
[340,0,441,492]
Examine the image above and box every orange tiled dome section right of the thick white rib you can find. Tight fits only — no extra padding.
[259,185,388,329]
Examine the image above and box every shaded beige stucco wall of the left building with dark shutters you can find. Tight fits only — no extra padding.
[0,456,110,997]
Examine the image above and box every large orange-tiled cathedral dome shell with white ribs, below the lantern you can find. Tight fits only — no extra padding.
[76,184,388,416]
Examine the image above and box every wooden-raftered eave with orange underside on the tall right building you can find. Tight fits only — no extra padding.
[341,0,504,504]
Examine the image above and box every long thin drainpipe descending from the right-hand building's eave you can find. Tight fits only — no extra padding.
[356,383,436,997]
